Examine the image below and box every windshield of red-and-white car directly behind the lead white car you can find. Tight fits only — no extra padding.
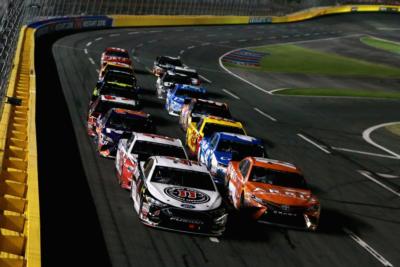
[131,141,186,161]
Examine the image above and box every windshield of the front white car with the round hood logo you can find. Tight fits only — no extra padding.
[151,166,215,191]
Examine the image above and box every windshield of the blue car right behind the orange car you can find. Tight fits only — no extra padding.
[217,140,264,160]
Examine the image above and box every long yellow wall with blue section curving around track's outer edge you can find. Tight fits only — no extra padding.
[0,5,400,267]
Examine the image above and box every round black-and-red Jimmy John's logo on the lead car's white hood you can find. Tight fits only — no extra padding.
[164,187,210,204]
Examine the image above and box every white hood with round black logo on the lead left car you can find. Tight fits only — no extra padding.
[148,182,222,211]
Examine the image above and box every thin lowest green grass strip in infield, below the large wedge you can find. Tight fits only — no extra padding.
[274,88,400,99]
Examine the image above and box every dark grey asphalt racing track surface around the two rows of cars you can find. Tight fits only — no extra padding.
[36,14,400,266]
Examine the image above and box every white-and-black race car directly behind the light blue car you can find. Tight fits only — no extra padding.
[156,70,192,99]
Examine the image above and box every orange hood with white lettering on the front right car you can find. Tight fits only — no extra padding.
[247,182,313,206]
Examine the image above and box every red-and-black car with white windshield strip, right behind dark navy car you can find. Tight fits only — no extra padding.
[87,95,138,136]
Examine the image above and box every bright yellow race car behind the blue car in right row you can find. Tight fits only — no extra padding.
[186,116,247,156]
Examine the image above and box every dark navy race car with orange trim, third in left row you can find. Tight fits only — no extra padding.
[95,108,155,158]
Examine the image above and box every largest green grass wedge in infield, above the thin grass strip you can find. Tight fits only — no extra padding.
[228,44,400,77]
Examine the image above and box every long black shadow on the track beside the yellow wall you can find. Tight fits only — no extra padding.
[35,30,111,267]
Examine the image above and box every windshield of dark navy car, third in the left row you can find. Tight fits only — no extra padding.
[106,113,153,133]
